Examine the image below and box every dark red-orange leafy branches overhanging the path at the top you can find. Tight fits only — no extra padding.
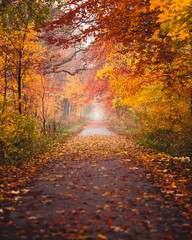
[43,0,189,95]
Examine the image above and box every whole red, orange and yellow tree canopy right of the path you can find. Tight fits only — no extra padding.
[45,0,191,157]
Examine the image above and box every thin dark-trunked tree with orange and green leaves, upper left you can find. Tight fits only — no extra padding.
[0,0,63,114]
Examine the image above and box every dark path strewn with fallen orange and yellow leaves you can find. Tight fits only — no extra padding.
[0,123,191,240]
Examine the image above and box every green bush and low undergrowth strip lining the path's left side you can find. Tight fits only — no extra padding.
[0,108,88,165]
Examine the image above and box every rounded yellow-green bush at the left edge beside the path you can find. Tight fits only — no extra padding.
[0,111,40,164]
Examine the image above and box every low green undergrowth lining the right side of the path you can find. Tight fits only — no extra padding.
[109,102,192,158]
